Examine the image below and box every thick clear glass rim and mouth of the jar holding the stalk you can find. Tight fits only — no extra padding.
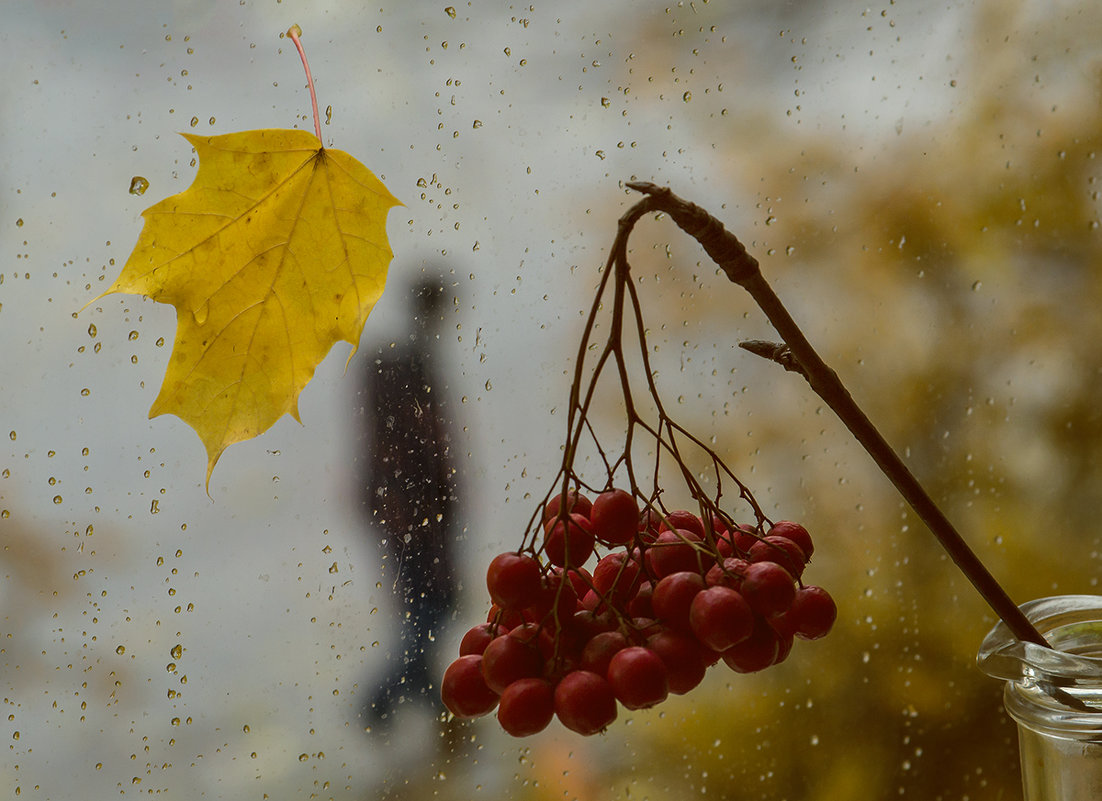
[976,595,1102,686]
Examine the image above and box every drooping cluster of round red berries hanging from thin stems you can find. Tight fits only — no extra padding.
[441,489,836,737]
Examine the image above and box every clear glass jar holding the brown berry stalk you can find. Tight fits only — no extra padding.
[977,595,1102,801]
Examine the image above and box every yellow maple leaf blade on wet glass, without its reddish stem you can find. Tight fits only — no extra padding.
[101,130,401,486]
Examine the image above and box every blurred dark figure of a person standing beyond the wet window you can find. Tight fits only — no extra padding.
[358,277,461,726]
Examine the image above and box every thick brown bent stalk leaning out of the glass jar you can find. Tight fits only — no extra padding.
[614,182,1048,647]
